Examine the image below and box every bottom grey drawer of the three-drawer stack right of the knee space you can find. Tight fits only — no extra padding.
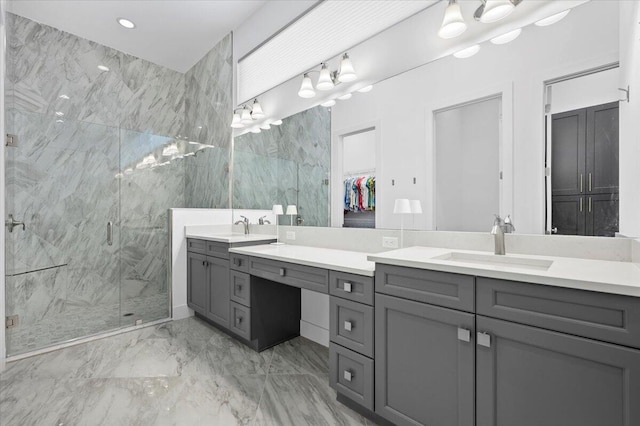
[329,343,373,411]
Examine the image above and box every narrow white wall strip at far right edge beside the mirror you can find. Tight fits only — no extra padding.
[619,1,640,237]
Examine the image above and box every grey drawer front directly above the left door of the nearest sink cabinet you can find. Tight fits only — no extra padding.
[376,264,475,312]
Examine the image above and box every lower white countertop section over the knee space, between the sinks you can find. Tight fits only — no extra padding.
[229,244,375,277]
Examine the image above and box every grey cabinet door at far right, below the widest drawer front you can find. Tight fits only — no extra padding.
[476,316,640,426]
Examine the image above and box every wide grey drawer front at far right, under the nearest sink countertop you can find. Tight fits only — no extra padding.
[477,277,640,348]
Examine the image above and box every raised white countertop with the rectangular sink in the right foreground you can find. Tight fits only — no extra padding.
[367,247,640,297]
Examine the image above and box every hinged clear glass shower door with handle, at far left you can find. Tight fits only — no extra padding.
[5,108,121,355]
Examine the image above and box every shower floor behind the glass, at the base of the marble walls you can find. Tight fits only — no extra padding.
[6,293,170,356]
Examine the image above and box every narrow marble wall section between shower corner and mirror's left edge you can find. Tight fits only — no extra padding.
[182,34,233,208]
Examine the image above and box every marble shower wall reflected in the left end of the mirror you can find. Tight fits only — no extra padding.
[233,106,331,226]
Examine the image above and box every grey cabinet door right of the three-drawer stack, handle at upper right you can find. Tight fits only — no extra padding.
[375,294,475,426]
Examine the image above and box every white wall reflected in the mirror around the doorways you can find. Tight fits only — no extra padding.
[331,2,616,234]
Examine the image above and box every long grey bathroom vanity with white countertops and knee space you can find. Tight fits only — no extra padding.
[188,235,640,426]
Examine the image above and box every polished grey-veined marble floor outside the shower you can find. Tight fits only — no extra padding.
[0,318,372,426]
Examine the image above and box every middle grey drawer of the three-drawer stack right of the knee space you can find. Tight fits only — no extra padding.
[329,297,373,357]
